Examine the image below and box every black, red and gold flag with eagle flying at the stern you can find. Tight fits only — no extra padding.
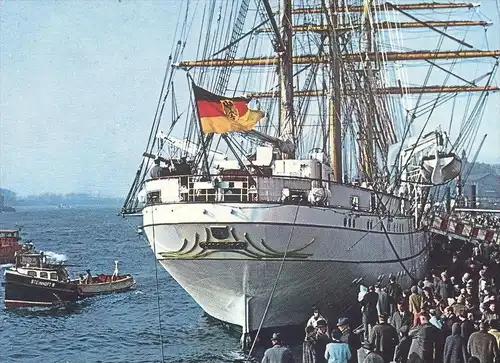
[193,84,265,134]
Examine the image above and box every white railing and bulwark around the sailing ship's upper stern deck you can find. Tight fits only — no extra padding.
[144,173,405,215]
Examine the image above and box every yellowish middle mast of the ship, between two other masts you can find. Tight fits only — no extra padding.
[327,0,342,182]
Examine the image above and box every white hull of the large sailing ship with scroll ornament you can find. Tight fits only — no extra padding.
[143,203,427,332]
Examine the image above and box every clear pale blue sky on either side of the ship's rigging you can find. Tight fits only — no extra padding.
[0,0,500,197]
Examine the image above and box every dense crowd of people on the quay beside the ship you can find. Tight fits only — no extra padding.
[262,239,500,363]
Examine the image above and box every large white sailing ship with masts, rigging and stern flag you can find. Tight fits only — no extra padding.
[122,0,500,344]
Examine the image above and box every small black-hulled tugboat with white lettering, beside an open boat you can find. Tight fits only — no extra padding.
[2,248,80,308]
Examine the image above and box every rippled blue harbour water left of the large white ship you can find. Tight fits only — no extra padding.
[0,207,254,363]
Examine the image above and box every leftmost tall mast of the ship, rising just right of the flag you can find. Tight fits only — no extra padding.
[279,0,295,159]
